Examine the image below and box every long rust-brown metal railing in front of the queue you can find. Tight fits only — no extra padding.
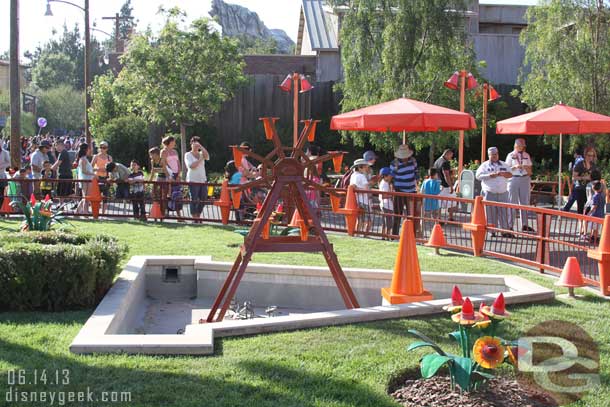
[0,179,603,285]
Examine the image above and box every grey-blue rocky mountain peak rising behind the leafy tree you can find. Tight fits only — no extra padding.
[210,0,296,54]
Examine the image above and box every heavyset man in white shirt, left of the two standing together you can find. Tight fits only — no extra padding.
[476,147,513,237]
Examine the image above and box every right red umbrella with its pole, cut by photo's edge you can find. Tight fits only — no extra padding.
[496,103,610,204]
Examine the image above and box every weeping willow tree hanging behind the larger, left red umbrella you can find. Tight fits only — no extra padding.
[333,0,478,150]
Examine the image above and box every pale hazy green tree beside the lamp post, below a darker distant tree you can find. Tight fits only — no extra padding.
[38,85,85,131]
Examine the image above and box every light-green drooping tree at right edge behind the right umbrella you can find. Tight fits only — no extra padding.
[520,0,610,151]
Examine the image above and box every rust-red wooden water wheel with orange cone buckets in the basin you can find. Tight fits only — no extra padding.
[200,117,360,322]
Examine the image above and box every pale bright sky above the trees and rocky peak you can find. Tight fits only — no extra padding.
[0,0,536,54]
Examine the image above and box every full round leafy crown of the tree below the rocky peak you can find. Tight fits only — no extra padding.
[117,9,246,132]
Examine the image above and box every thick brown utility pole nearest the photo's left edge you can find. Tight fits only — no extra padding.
[9,0,21,168]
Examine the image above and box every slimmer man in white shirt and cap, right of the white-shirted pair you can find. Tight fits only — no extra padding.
[505,138,534,232]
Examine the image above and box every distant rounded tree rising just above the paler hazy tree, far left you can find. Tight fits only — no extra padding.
[32,53,78,90]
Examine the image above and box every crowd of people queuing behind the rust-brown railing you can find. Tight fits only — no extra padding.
[0,135,605,238]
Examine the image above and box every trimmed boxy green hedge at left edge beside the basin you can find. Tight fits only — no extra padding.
[0,232,127,311]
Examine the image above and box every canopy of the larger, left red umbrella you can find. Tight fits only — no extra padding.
[330,98,477,132]
